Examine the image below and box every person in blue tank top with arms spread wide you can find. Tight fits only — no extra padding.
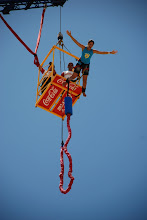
[63,30,118,97]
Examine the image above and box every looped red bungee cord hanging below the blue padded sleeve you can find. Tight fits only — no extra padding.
[59,114,74,194]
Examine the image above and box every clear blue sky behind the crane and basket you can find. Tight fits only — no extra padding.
[0,0,147,220]
